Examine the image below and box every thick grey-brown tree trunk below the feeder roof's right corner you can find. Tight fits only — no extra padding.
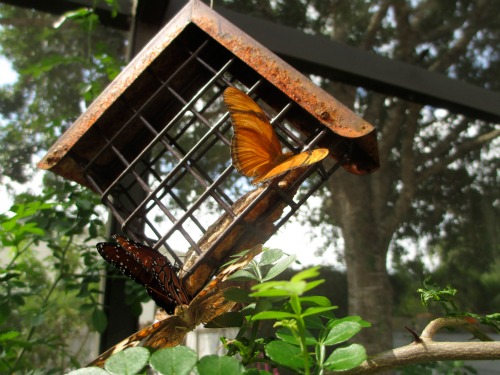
[328,172,392,354]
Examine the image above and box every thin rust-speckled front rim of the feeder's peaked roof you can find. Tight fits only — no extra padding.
[37,0,378,173]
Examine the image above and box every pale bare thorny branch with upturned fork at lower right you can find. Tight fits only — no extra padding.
[336,318,500,375]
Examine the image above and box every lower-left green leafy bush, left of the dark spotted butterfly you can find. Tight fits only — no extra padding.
[0,187,107,373]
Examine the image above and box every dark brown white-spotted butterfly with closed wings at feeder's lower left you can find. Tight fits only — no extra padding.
[96,234,190,314]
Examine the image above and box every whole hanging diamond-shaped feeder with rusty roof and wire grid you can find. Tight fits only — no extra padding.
[39,1,378,293]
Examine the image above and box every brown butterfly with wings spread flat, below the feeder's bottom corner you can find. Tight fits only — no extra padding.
[87,245,262,367]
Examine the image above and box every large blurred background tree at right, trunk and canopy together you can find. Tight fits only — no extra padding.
[220,0,500,353]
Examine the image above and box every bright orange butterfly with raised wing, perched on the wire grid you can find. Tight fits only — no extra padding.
[224,87,328,185]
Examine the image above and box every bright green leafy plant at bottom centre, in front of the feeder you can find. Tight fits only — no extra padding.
[77,249,369,375]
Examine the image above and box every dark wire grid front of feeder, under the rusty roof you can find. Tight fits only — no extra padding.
[80,25,349,265]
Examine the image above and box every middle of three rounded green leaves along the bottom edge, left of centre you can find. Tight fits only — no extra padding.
[149,346,198,375]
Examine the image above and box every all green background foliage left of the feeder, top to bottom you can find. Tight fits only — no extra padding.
[0,4,127,373]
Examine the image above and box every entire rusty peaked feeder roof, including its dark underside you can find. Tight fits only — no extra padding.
[38,0,379,186]
